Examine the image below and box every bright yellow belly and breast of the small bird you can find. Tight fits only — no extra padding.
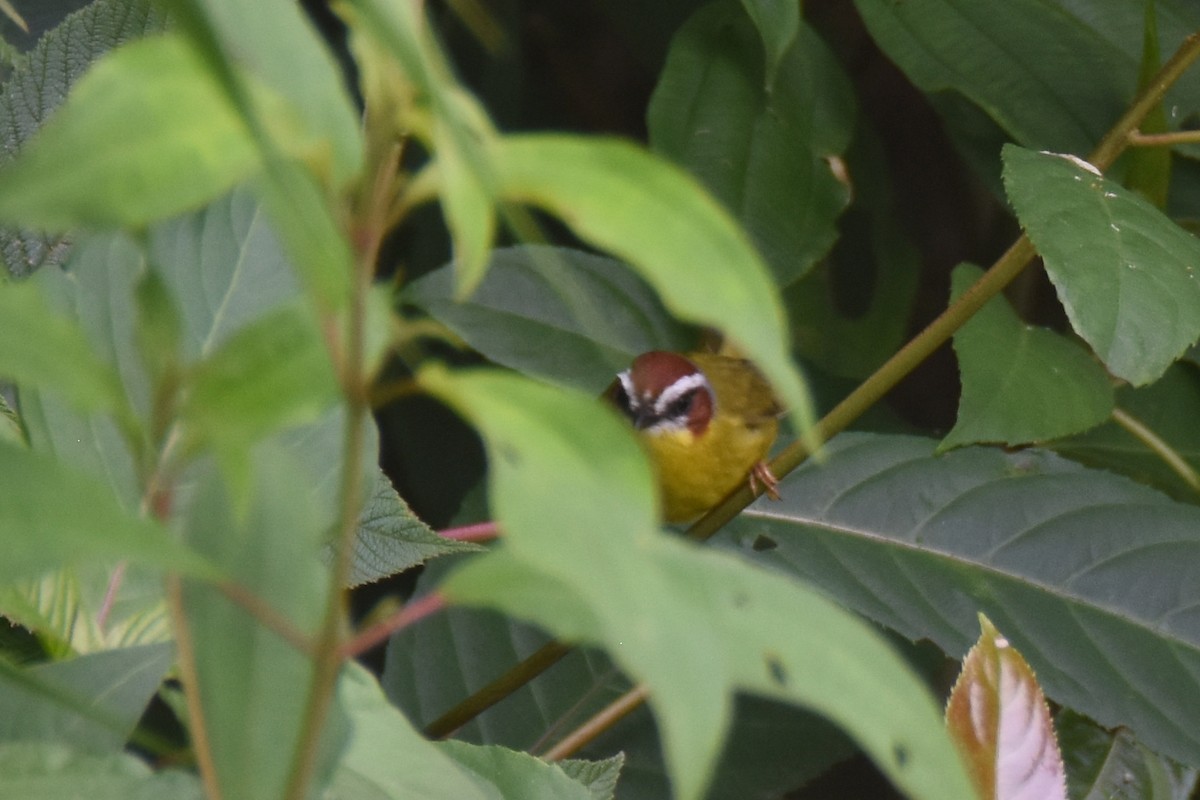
[643,414,779,523]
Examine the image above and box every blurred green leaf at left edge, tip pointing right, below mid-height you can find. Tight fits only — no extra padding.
[0,444,220,585]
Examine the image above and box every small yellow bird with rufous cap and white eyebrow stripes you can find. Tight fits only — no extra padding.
[605,350,782,523]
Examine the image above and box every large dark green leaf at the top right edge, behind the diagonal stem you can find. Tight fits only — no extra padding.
[854,0,1200,156]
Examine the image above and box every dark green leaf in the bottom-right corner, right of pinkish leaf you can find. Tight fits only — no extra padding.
[1055,709,1196,800]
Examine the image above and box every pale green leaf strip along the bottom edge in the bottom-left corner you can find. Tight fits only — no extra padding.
[0,742,204,800]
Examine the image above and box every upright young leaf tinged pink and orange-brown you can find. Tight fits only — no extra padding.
[946,614,1067,800]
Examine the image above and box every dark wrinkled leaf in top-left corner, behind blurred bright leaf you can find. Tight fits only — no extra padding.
[0,0,166,275]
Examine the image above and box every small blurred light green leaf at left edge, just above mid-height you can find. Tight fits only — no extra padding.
[0,282,125,419]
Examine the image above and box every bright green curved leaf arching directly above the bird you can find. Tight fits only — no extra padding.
[492,134,812,429]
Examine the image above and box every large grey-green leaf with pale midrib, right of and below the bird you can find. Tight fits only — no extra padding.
[718,434,1200,763]
